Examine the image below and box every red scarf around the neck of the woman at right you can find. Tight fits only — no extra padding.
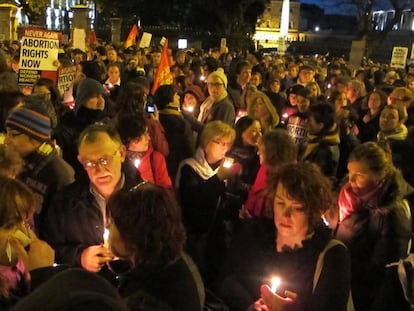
[338,182,384,222]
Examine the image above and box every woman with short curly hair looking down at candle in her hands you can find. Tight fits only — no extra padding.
[221,162,350,311]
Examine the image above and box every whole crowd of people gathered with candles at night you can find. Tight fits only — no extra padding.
[0,37,414,311]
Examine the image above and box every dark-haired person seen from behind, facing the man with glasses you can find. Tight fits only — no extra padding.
[108,182,204,311]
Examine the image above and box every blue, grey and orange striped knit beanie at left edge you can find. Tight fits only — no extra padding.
[6,104,52,142]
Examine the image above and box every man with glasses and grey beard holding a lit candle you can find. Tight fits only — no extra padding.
[46,123,142,272]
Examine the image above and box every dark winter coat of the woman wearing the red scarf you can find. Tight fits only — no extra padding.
[335,171,411,311]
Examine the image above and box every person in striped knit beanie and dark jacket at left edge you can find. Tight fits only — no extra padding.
[5,104,74,238]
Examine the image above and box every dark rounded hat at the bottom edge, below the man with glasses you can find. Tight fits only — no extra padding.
[13,268,127,311]
